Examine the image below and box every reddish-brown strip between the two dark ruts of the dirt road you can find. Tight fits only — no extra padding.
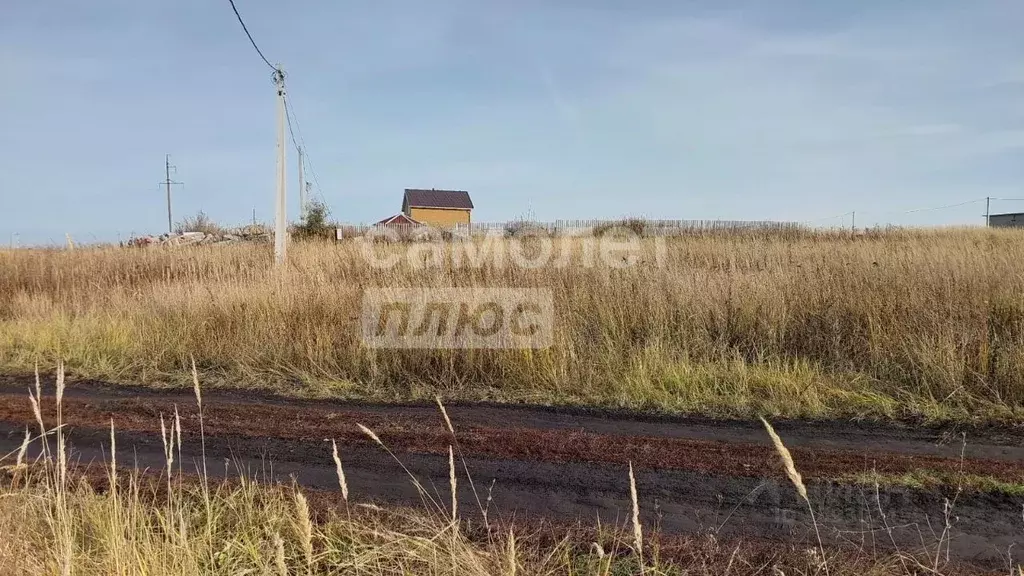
[0,394,1024,483]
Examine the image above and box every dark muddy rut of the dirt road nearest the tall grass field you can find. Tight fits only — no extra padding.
[0,375,1024,461]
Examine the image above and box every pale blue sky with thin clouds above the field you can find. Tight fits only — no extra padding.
[0,0,1024,244]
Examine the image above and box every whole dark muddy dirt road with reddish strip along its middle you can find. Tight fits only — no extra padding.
[0,377,1024,568]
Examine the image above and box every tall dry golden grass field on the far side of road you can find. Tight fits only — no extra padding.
[0,230,1024,418]
